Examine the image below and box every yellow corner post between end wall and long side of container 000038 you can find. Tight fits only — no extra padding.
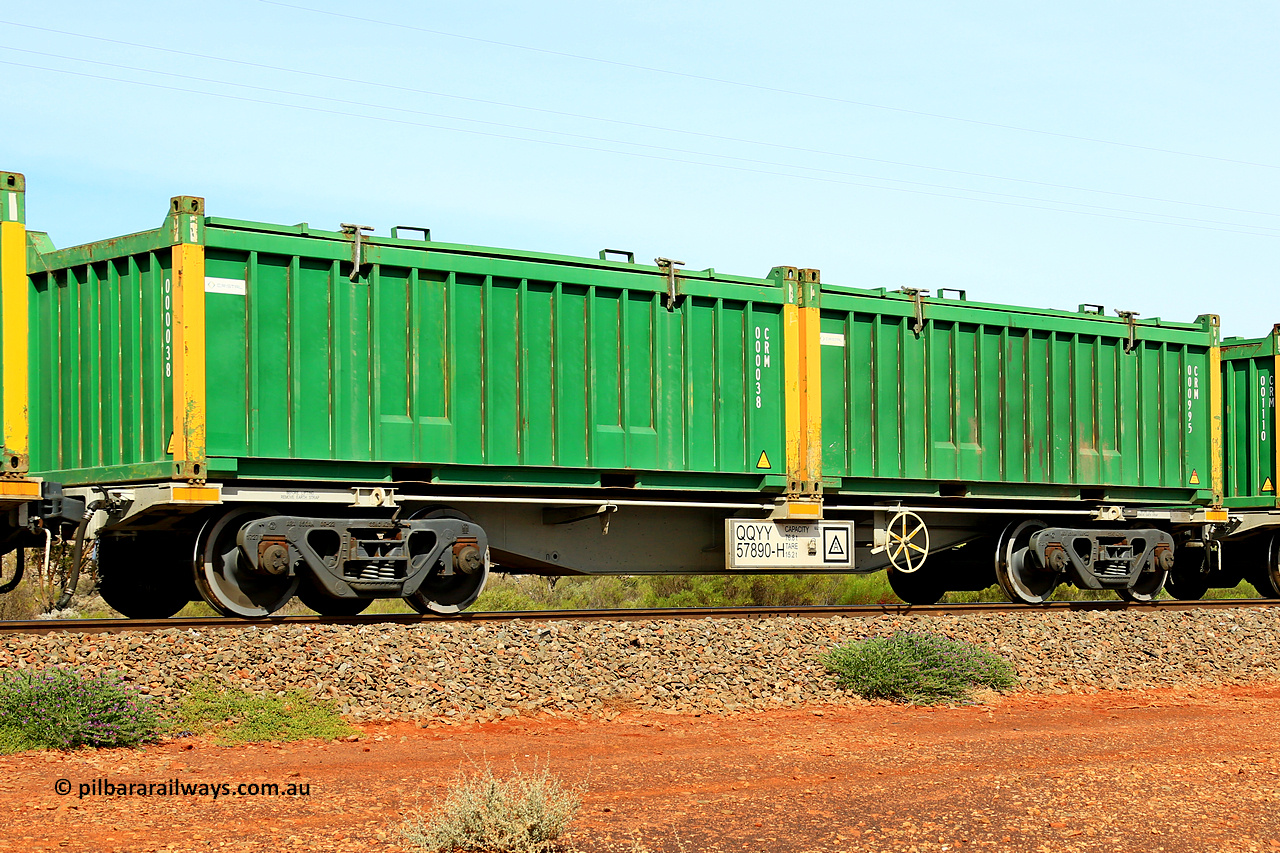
[165,196,209,483]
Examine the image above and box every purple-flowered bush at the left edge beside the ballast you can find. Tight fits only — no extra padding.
[0,669,160,752]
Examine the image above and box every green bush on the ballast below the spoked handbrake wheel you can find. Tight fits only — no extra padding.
[820,631,1018,704]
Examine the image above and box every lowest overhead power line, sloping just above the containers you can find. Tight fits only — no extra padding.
[0,60,1280,237]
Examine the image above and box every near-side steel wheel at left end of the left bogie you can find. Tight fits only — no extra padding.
[195,508,298,619]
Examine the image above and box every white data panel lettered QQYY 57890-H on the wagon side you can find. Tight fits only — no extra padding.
[724,519,854,569]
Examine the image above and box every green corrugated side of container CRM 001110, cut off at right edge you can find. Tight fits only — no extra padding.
[1222,336,1277,507]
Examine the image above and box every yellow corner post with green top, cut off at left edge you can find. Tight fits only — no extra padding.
[0,172,31,474]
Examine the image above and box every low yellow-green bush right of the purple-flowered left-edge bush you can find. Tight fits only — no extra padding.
[172,681,356,744]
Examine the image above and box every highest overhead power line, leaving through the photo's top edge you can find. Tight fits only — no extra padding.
[259,0,1280,169]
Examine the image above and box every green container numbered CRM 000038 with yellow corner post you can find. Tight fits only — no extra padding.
[27,189,795,491]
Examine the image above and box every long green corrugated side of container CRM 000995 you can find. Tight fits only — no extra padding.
[822,291,1213,501]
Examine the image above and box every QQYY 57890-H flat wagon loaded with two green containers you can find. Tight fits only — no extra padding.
[0,167,1222,617]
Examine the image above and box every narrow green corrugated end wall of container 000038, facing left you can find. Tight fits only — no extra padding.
[29,232,173,484]
